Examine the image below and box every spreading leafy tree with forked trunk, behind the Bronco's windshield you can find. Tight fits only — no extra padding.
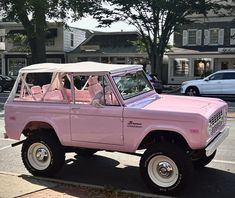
[94,0,230,79]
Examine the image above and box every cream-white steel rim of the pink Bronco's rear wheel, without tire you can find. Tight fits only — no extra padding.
[27,143,51,170]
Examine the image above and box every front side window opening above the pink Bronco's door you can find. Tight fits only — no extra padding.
[74,75,119,106]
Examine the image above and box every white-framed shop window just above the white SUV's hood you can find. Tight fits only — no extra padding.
[174,59,189,76]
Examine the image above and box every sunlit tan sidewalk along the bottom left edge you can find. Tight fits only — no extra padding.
[0,172,162,198]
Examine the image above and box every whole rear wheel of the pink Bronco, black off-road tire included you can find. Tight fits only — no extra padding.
[21,131,65,177]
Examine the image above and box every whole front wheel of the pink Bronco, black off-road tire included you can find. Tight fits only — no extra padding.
[140,143,193,195]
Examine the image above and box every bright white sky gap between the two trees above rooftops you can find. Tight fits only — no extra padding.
[68,17,136,32]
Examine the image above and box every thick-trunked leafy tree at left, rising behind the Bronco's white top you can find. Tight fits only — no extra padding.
[0,0,100,63]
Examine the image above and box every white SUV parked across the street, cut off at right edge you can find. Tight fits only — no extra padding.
[181,70,235,96]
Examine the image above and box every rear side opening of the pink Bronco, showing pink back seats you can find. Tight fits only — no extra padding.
[14,73,71,103]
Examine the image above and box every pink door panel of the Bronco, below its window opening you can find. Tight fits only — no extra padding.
[71,104,123,145]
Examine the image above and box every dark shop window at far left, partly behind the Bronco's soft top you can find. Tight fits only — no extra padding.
[8,58,27,76]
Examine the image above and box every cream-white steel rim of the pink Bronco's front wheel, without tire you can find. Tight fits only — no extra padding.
[148,155,179,187]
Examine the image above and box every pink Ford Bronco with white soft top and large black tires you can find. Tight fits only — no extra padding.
[5,62,229,194]
